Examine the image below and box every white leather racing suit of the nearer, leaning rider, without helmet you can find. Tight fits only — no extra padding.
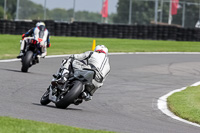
[61,51,110,96]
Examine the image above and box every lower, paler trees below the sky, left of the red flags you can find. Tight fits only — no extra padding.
[0,0,101,22]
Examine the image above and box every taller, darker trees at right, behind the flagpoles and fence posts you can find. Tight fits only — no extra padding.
[113,0,200,28]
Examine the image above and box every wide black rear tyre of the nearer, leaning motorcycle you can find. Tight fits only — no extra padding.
[56,80,83,109]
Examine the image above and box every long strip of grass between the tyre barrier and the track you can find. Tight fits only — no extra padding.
[0,34,200,59]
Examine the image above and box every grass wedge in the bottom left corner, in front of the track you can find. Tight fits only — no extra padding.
[0,117,114,133]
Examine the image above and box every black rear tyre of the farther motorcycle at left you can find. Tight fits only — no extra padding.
[21,51,33,72]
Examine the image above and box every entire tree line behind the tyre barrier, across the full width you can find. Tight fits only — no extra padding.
[0,0,200,27]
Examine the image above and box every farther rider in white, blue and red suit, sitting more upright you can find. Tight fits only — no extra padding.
[17,22,51,58]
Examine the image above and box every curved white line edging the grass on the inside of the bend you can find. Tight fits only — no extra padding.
[157,82,200,127]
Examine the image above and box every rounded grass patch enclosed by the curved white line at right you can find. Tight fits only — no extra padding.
[167,86,200,124]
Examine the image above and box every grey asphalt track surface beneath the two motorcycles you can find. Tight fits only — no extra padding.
[0,54,200,133]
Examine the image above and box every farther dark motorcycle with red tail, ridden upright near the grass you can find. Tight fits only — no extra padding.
[21,37,42,72]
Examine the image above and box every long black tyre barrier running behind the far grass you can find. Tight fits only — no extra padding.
[0,20,200,41]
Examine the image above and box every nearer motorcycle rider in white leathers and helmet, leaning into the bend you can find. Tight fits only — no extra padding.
[52,45,110,104]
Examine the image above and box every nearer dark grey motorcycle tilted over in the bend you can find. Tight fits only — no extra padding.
[40,69,95,109]
